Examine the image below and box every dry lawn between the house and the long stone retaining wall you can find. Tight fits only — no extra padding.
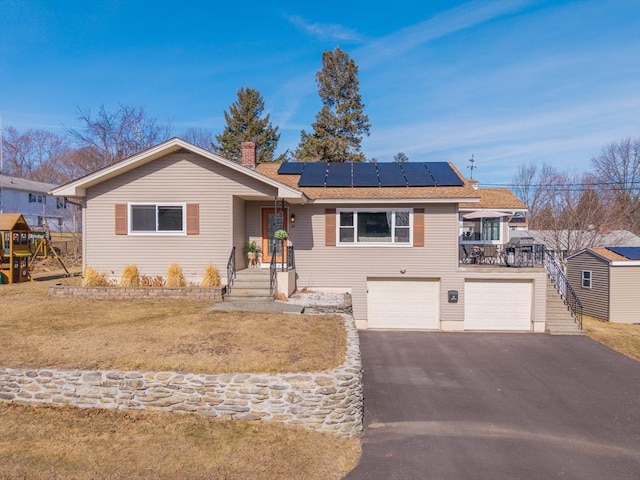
[0,280,346,374]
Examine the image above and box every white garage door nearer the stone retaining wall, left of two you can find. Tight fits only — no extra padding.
[367,278,440,330]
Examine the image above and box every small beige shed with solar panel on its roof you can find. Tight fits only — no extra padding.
[567,247,640,323]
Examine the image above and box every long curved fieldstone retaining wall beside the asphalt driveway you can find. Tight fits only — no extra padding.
[0,316,363,437]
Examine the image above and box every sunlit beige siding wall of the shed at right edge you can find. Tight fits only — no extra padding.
[609,265,640,323]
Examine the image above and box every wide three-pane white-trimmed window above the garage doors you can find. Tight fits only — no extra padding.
[337,209,412,246]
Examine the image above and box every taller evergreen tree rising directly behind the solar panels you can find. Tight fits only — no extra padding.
[295,48,370,162]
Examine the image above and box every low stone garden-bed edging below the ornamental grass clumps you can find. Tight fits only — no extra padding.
[48,285,222,302]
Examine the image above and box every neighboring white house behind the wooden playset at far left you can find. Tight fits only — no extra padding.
[0,174,81,232]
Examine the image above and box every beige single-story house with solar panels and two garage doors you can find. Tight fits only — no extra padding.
[53,138,546,332]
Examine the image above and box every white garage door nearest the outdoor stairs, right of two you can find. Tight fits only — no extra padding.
[464,280,532,330]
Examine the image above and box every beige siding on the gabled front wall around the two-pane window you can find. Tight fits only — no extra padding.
[84,153,275,281]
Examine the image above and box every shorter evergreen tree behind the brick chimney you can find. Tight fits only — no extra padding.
[216,88,281,163]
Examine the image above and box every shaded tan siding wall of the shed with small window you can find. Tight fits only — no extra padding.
[567,252,609,320]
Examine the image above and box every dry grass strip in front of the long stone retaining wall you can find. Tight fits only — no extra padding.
[0,403,360,480]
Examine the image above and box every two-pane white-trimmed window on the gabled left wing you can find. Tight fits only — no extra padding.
[129,203,186,234]
